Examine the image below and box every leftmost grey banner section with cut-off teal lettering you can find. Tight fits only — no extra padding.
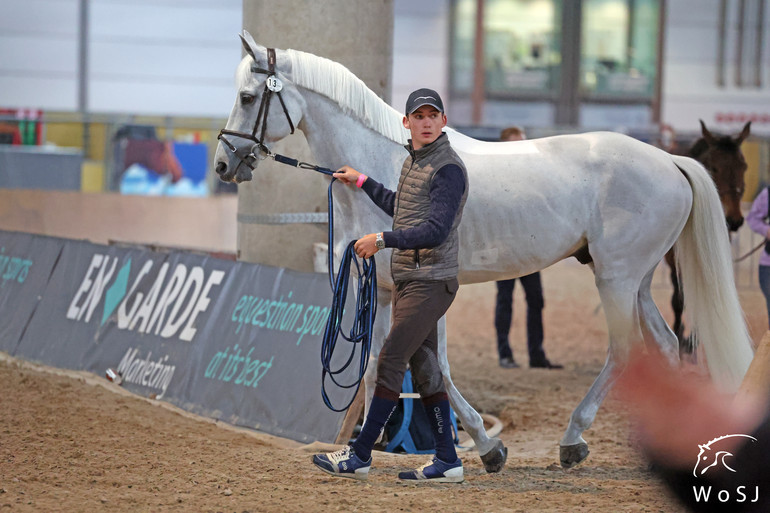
[0,231,64,354]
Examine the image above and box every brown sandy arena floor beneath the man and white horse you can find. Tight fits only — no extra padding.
[0,260,767,513]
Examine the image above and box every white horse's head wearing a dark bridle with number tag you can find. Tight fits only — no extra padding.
[215,30,304,183]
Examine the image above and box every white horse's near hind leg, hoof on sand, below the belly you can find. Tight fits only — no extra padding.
[559,275,641,468]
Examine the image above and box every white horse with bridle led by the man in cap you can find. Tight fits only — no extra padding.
[216,33,753,472]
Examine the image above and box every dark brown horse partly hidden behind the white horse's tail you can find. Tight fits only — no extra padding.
[666,120,751,353]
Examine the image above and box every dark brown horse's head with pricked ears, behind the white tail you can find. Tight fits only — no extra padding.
[690,121,751,232]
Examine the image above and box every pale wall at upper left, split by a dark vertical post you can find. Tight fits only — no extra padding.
[0,0,242,117]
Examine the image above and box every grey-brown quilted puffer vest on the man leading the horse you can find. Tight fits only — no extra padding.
[391,133,468,282]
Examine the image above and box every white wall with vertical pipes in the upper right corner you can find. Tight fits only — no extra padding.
[661,0,770,135]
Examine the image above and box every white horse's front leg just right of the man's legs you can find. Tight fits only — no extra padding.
[438,316,508,472]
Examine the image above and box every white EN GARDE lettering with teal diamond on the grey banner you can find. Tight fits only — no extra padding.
[67,253,225,342]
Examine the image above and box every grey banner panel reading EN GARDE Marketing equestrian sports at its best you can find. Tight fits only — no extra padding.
[15,241,350,442]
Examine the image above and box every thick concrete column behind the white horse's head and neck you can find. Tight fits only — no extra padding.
[233,0,393,271]
